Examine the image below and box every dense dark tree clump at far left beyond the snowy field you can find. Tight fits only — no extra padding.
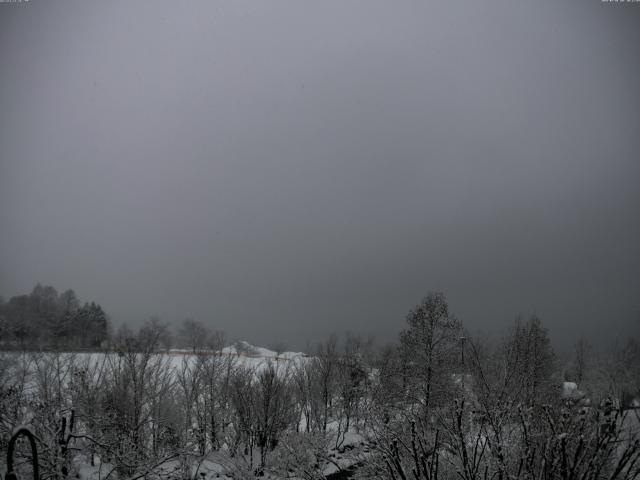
[0,284,110,350]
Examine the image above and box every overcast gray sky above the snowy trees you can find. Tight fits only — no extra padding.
[0,0,640,347]
